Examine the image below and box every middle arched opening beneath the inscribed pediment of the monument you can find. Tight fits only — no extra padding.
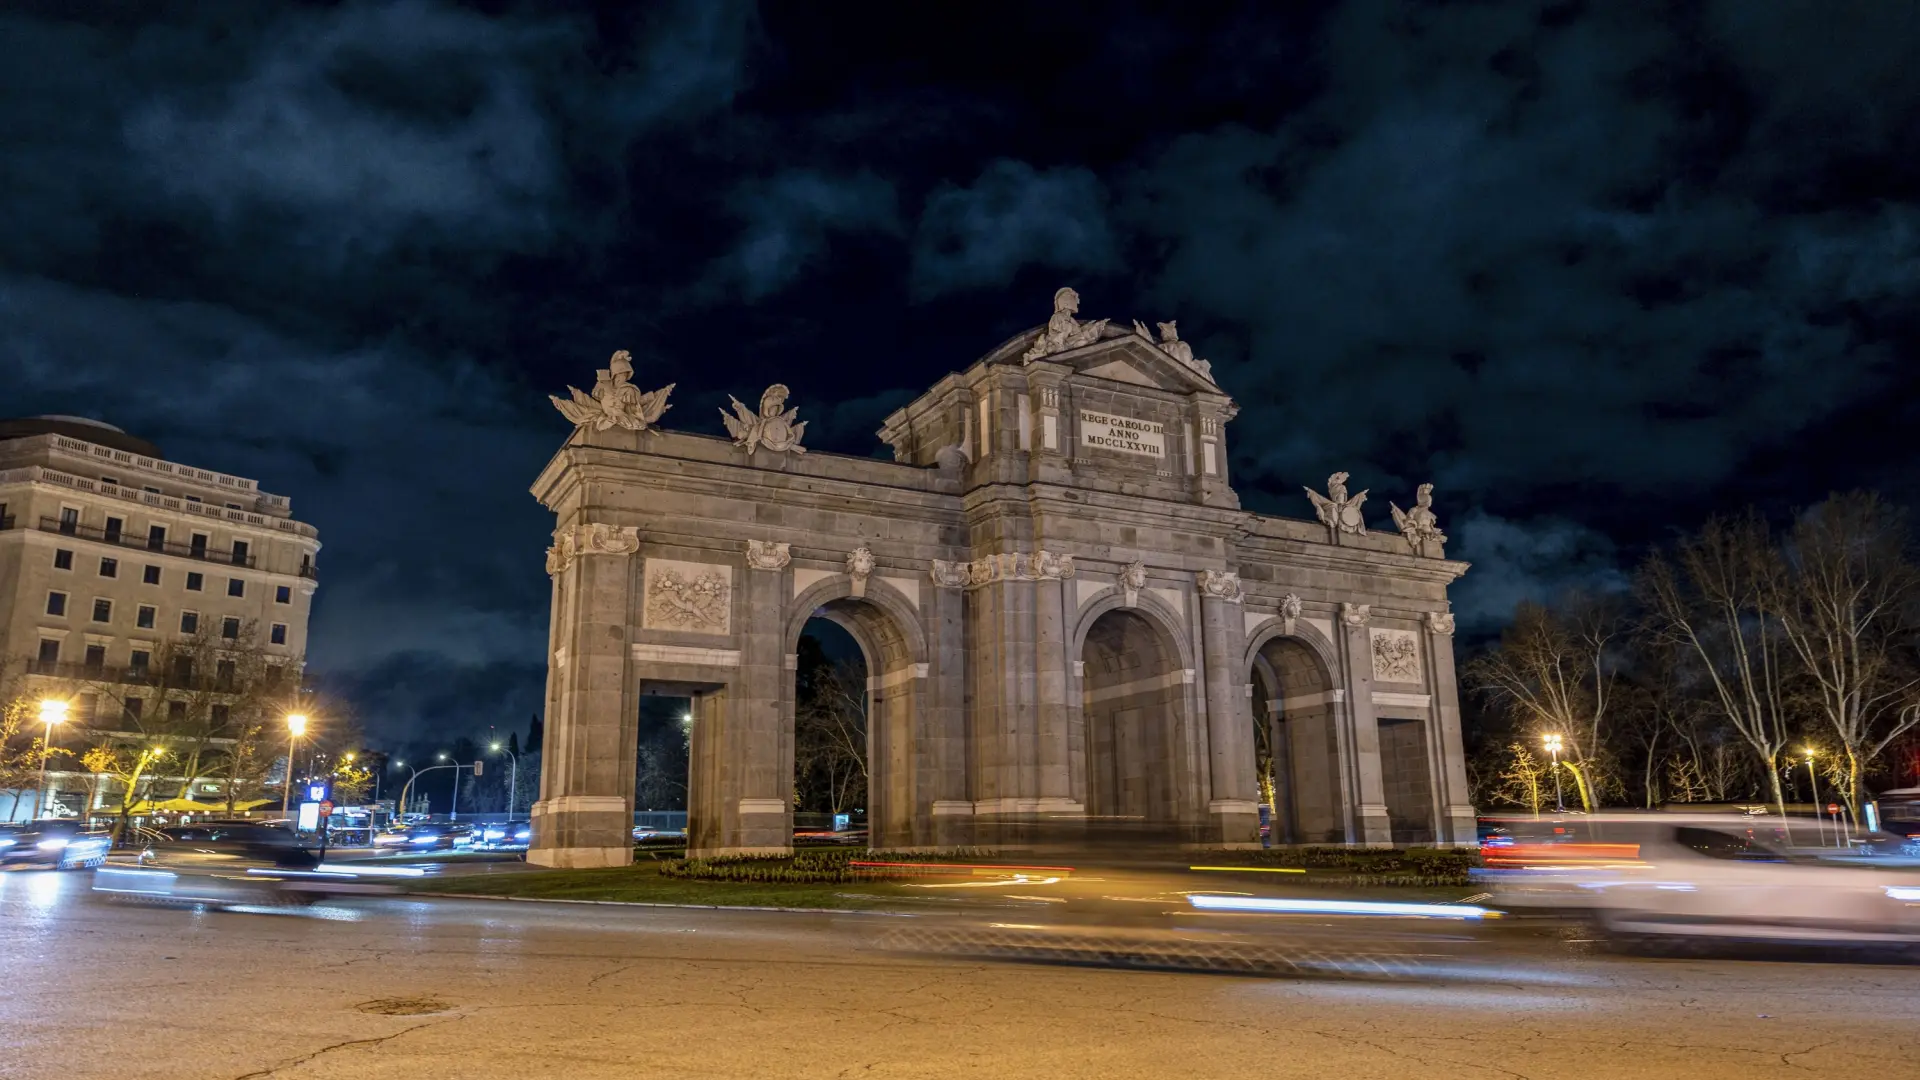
[1071,605,1196,826]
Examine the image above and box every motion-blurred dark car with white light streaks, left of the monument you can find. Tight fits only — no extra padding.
[94,821,407,907]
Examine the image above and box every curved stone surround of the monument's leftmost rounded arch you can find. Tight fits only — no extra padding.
[776,575,933,849]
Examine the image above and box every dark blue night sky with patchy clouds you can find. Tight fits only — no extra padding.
[0,0,1920,742]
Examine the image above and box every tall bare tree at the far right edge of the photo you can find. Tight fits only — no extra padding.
[1772,492,1920,821]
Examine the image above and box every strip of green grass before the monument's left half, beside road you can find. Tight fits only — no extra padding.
[409,861,906,911]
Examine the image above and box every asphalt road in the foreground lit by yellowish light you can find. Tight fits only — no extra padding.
[0,872,1920,1080]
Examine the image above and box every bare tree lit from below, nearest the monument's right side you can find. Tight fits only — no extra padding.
[1467,596,1620,811]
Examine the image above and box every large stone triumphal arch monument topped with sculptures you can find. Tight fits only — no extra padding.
[528,288,1475,867]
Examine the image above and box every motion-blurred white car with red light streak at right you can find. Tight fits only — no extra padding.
[1476,813,1920,955]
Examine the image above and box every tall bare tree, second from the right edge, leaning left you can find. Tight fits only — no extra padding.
[1640,513,1791,817]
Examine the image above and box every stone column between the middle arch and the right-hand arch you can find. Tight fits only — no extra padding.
[1198,571,1260,847]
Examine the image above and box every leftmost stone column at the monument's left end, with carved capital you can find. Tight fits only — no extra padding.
[526,523,639,867]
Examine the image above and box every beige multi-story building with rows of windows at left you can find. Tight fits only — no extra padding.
[0,417,321,813]
